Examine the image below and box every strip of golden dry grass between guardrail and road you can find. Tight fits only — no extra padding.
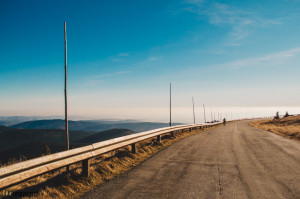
[0,127,219,198]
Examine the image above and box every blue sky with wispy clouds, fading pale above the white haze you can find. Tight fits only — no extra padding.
[0,0,300,121]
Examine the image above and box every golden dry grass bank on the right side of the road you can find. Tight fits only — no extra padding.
[250,115,300,140]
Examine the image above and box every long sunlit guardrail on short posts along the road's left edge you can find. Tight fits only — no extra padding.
[0,123,220,190]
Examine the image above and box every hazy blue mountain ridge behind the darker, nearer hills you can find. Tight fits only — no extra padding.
[10,119,179,132]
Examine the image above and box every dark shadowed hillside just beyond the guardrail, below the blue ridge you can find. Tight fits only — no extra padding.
[0,126,134,164]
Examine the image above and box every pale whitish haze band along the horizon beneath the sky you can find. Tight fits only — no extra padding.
[0,106,300,123]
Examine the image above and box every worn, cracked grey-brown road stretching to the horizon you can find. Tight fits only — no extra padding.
[83,121,300,199]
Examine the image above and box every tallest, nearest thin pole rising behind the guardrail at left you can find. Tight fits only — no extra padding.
[65,22,70,150]
